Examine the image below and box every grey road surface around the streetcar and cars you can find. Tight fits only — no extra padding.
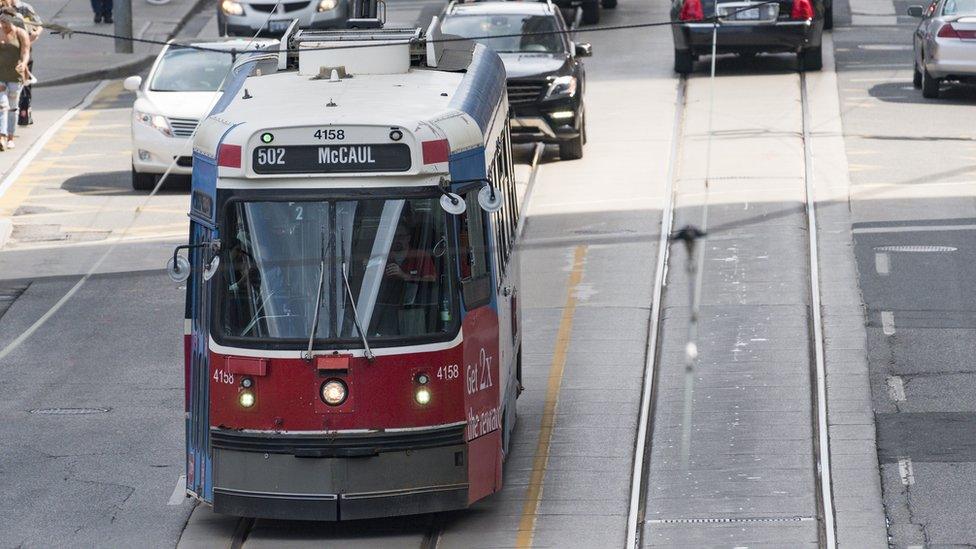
[0,0,976,547]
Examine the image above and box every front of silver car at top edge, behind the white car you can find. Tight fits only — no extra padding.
[217,0,349,36]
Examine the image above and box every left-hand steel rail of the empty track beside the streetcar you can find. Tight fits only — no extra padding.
[625,76,688,548]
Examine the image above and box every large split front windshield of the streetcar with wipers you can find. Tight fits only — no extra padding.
[220,198,456,343]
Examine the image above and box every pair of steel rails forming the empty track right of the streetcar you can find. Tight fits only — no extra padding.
[625,72,836,549]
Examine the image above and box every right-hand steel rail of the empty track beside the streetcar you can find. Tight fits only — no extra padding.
[800,71,837,549]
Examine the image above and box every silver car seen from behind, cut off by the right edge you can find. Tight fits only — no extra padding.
[908,0,976,99]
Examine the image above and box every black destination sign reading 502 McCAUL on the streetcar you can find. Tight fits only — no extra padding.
[251,143,411,174]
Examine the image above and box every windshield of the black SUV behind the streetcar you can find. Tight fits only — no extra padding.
[441,15,566,53]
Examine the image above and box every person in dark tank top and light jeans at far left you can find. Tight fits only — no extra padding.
[0,8,30,151]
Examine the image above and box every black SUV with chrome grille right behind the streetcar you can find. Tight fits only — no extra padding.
[440,2,591,159]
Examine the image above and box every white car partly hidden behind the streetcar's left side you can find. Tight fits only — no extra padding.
[123,39,278,190]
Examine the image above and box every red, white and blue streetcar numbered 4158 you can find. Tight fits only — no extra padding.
[168,12,521,521]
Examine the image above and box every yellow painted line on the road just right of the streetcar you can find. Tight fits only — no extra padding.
[515,246,587,548]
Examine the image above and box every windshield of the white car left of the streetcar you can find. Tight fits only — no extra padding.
[149,48,233,92]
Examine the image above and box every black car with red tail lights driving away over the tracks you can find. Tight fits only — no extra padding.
[671,0,831,74]
